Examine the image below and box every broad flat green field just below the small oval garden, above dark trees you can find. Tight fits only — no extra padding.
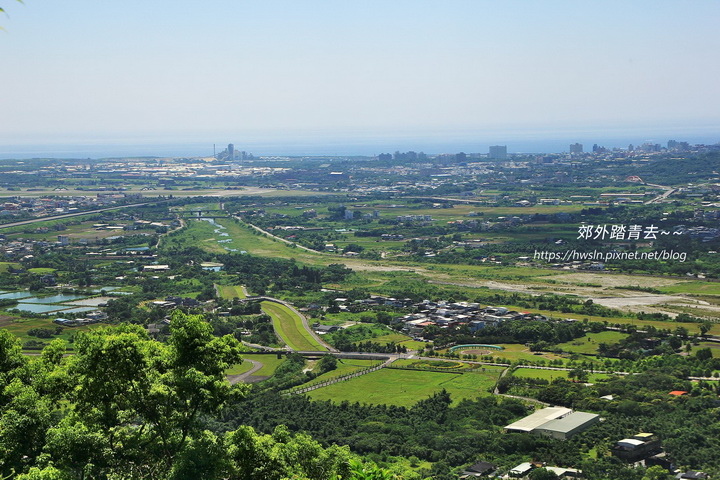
[308,367,502,407]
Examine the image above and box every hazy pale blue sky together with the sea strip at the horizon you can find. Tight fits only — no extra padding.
[0,0,720,156]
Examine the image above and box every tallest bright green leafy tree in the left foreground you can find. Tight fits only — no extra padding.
[26,311,244,478]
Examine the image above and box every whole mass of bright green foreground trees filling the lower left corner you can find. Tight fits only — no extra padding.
[0,311,391,480]
